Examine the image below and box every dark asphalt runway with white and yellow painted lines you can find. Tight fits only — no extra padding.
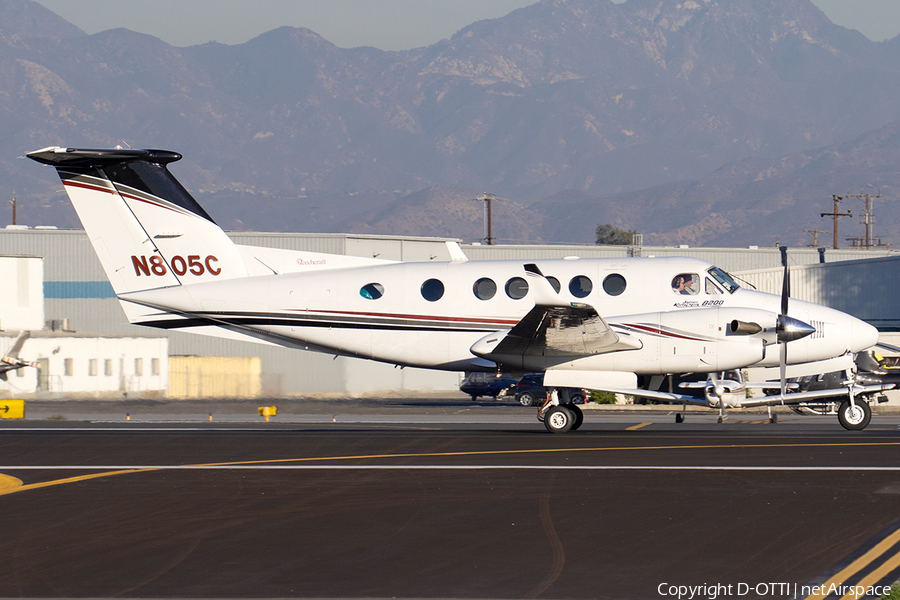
[0,402,900,599]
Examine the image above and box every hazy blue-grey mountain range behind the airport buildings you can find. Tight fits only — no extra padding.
[0,0,900,245]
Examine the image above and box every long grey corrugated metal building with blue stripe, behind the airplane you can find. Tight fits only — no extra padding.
[0,229,900,395]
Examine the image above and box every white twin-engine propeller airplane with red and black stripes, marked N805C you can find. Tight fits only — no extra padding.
[28,147,892,433]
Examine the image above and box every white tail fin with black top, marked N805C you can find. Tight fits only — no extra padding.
[27,147,247,295]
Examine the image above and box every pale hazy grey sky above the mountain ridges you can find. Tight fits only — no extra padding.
[38,0,900,50]
